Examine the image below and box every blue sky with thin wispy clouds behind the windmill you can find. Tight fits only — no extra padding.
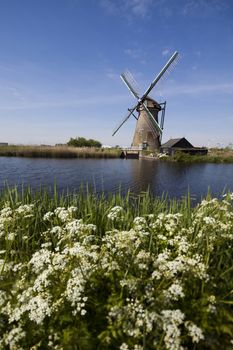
[0,0,233,146]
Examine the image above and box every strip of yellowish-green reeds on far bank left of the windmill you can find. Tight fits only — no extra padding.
[0,146,121,158]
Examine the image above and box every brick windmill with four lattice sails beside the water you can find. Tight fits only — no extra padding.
[112,51,178,151]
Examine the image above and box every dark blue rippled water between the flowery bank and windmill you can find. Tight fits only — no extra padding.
[0,157,233,200]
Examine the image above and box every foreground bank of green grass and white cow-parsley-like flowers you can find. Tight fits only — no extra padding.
[0,188,233,350]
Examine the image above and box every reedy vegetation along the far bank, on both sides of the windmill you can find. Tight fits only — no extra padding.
[0,145,233,163]
